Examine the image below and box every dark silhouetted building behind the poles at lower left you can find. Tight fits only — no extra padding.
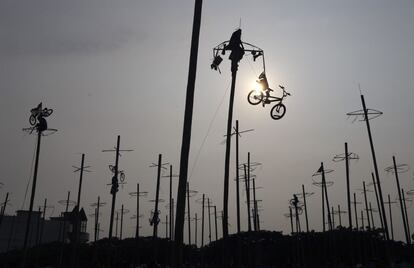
[0,207,89,252]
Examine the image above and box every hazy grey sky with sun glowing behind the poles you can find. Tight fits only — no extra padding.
[0,0,414,241]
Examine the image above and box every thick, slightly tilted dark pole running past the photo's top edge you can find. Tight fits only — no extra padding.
[173,0,203,268]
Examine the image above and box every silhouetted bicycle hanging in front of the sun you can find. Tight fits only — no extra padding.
[247,85,290,120]
